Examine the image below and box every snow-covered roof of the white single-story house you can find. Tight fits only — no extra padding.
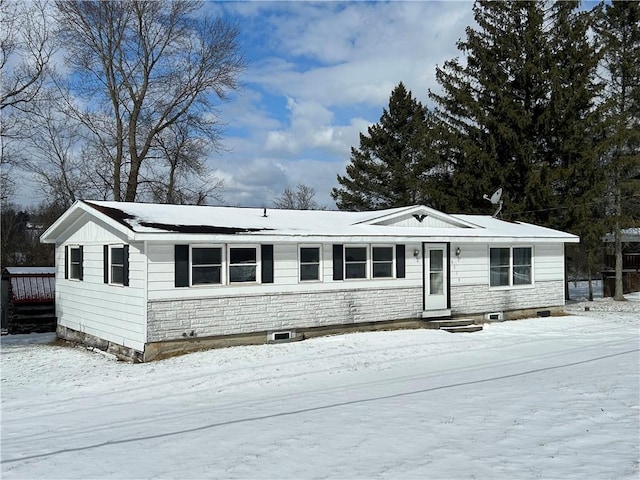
[41,201,578,243]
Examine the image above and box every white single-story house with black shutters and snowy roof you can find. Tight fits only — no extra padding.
[41,201,579,361]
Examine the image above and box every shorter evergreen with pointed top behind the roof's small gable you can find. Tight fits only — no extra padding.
[331,82,440,210]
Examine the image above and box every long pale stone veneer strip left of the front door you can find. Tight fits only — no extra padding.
[147,287,422,342]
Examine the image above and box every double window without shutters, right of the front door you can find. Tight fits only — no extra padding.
[489,247,533,287]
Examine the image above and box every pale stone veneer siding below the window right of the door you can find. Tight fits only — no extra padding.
[451,280,564,316]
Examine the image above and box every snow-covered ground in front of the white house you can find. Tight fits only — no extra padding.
[1,286,640,479]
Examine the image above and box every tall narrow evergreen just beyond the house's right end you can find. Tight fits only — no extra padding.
[544,1,606,296]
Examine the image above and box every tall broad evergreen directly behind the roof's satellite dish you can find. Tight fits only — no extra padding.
[430,1,549,220]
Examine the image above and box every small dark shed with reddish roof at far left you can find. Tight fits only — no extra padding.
[0,267,56,334]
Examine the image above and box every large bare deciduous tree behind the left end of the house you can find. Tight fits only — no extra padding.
[56,0,245,201]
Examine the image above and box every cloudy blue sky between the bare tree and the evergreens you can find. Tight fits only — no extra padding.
[198,1,473,208]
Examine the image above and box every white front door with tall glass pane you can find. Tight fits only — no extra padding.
[423,243,449,311]
